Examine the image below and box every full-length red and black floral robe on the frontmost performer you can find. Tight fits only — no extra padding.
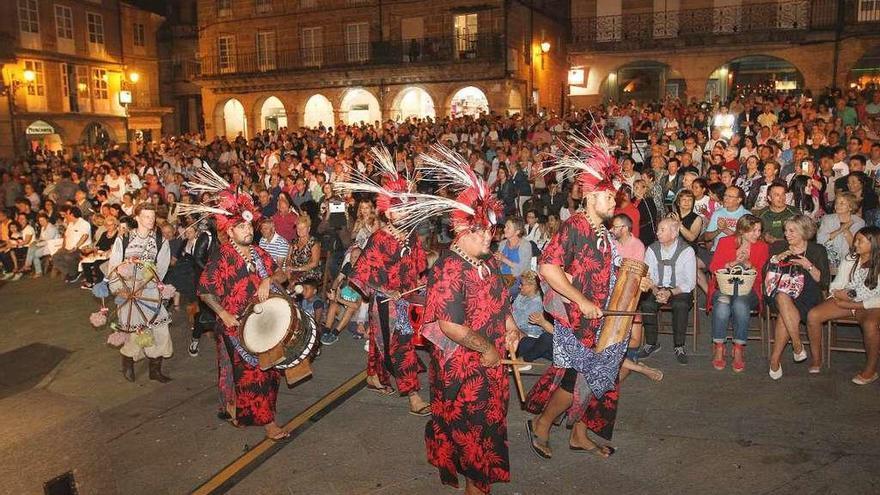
[422,251,510,492]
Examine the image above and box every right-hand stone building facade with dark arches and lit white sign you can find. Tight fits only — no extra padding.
[568,0,880,107]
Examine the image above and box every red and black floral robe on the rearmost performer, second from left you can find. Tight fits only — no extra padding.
[350,229,428,395]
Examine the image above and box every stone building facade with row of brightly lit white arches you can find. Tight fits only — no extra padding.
[198,0,568,138]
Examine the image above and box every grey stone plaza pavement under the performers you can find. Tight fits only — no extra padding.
[0,278,880,495]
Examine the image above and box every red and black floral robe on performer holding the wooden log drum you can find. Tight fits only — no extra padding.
[525,213,620,440]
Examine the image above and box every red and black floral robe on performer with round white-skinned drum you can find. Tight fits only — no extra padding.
[198,243,281,426]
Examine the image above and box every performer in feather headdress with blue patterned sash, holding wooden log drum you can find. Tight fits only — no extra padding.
[525,130,625,459]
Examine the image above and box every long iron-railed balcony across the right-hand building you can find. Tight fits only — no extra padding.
[571,0,880,52]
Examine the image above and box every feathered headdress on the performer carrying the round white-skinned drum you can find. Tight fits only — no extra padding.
[177,162,262,231]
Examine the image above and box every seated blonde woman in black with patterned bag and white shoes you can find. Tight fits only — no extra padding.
[764,215,831,380]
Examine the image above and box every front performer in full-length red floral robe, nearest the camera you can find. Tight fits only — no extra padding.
[402,146,521,495]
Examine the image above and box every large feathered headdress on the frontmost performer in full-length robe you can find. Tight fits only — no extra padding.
[391,145,503,232]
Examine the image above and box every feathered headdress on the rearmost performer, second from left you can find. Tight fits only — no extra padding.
[333,146,414,213]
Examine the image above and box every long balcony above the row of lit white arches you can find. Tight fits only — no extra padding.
[200,33,504,78]
